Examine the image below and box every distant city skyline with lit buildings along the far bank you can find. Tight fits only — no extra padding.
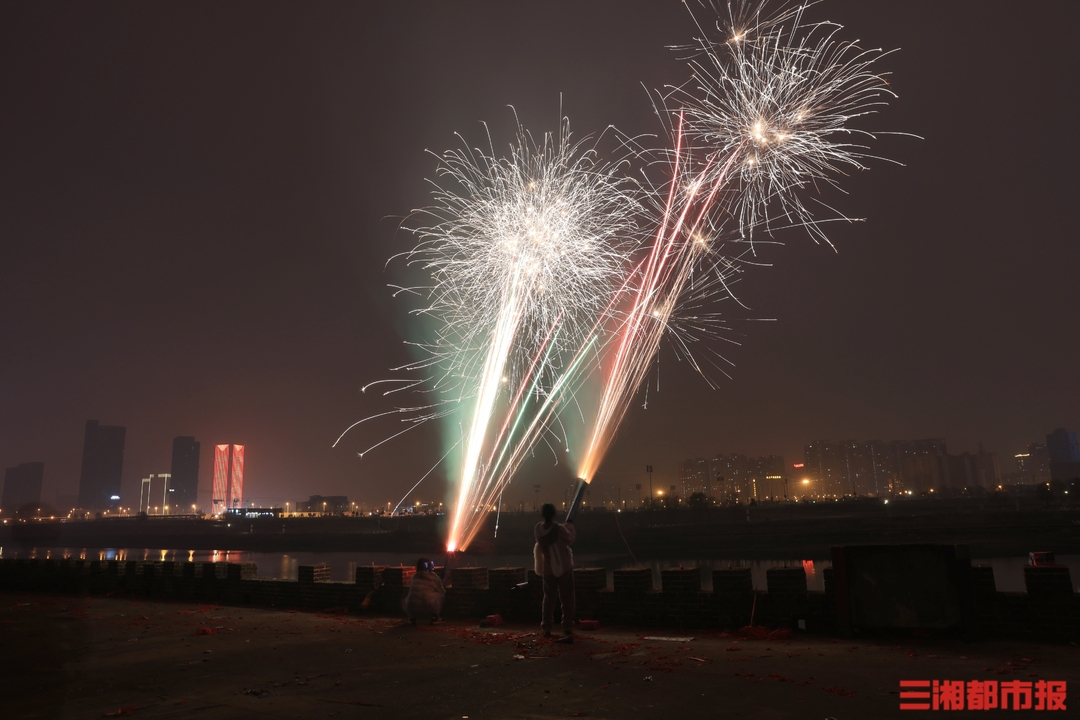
[4,420,1080,514]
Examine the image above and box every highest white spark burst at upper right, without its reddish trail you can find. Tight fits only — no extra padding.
[667,3,894,243]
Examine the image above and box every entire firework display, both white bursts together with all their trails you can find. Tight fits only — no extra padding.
[339,4,892,551]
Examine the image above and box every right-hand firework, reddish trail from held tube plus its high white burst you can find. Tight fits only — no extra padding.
[578,4,892,481]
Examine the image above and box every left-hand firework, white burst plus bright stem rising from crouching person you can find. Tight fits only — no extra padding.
[397,121,640,549]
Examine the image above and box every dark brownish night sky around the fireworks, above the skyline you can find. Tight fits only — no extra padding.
[0,0,1080,511]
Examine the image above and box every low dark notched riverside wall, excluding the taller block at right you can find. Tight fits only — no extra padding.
[0,559,1080,640]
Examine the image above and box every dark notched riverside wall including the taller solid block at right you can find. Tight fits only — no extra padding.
[0,545,1080,640]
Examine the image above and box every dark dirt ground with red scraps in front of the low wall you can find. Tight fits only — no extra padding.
[0,593,1080,720]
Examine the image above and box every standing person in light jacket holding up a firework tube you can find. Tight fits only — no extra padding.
[534,503,577,644]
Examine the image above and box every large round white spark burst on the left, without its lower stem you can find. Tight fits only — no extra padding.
[404,119,642,396]
